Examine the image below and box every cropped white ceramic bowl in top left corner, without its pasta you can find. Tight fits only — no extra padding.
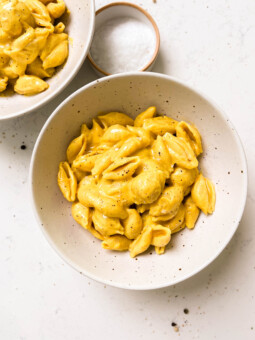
[0,0,95,120]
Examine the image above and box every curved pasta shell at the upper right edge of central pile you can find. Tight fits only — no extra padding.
[176,121,203,156]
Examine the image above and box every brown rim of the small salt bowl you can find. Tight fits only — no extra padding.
[88,1,160,76]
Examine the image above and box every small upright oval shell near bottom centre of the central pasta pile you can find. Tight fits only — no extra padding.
[122,209,143,240]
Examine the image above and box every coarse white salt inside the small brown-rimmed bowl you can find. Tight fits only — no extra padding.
[90,17,156,74]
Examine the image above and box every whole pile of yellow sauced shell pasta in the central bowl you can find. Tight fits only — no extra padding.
[58,107,215,257]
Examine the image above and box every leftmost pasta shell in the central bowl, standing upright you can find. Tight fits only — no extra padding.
[58,162,77,202]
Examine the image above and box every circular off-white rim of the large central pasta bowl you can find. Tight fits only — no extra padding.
[28,72,248,290]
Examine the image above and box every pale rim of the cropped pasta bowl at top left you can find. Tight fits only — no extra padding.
[0,0,95,121]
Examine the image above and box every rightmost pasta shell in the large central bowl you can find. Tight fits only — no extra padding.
[191,174,216,215]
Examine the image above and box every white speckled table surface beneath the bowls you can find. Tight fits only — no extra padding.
[0,0,255,340]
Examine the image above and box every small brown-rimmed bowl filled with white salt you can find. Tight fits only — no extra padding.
[88,2,160,77]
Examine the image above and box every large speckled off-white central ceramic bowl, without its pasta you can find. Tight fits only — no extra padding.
[30,72,247,289]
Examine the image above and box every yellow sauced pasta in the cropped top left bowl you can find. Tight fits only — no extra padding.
[0,0,68,95]
